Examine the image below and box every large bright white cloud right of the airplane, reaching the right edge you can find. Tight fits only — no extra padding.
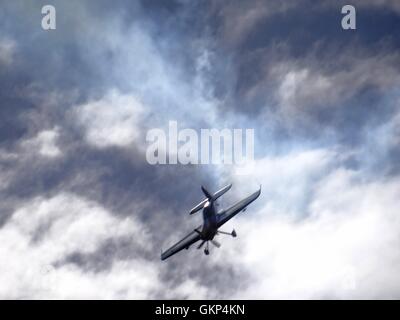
[223,150,400,299]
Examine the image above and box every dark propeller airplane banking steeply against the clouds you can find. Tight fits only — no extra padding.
[161,184,261,260]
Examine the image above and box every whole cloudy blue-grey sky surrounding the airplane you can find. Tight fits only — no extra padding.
[0,0,400,299]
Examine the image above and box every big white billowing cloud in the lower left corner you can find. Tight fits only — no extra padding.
[0,193,158,299]
